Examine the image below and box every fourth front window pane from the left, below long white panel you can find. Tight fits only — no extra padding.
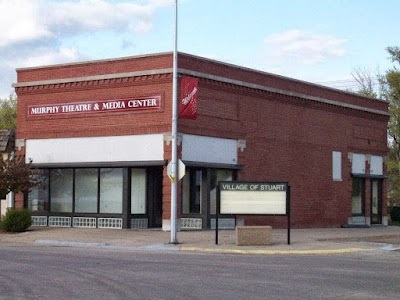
[100,168,123,214]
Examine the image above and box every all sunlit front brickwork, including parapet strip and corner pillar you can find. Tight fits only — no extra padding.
[16,56,172,224]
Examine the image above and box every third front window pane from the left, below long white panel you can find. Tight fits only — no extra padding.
[75,169,98,213]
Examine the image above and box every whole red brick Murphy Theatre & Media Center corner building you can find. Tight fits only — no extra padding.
[14,53,389,230]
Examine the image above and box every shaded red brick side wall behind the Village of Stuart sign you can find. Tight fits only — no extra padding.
[179,80,388,227]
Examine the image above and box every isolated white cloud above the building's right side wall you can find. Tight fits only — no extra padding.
[264,30,346,65]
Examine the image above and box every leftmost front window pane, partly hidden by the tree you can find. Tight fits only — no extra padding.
[28,169,49,211]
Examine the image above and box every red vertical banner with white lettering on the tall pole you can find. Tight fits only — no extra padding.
[179,77,198,120]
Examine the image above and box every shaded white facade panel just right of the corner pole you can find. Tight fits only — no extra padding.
[182,134,237,165]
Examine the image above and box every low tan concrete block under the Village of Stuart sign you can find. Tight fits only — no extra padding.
[236,226,272,246]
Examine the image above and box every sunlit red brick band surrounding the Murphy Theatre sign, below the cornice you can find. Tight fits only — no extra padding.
[17,77,172,139]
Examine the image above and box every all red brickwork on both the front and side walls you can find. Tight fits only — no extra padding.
[17,54,388,227]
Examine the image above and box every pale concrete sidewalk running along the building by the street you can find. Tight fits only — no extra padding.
[0,226,400,254]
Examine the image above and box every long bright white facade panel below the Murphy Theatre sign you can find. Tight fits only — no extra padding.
[25,134,164,164]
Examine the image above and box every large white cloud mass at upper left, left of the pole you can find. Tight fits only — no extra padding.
[0,0,173,97]
